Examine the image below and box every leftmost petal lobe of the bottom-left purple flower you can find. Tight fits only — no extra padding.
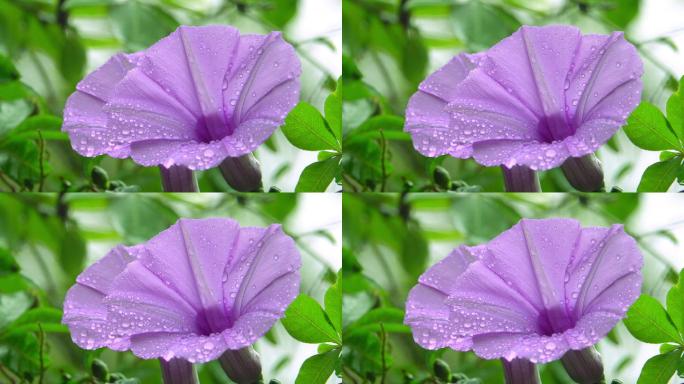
[62,246,139,350]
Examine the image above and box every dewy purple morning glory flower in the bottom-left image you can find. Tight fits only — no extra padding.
[63,218,301,382]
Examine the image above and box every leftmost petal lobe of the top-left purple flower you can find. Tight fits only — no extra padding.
[62,54,139,157]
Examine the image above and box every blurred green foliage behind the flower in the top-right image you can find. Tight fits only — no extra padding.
[342,0,679,192]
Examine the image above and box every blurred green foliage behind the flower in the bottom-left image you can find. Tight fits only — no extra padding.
[0,193,341,384]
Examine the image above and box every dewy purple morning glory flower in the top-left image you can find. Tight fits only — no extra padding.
[62,25,301,190]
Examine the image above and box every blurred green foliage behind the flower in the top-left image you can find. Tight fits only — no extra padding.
[0,0,341,192]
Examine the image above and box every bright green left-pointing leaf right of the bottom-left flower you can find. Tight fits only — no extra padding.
[281,293,342,344]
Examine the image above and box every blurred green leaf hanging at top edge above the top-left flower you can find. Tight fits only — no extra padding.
[109,0,178,52]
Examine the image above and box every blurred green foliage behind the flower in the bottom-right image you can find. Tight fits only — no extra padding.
[342,193,681,384]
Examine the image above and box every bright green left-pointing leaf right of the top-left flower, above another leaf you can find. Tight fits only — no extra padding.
[282,101,342,152]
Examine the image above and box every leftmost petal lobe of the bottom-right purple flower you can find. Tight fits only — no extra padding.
[404,248,475,350]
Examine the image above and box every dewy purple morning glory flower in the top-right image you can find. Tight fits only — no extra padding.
[405,25,643,190]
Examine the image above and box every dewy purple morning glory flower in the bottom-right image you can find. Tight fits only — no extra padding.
[405,219,642,383]
